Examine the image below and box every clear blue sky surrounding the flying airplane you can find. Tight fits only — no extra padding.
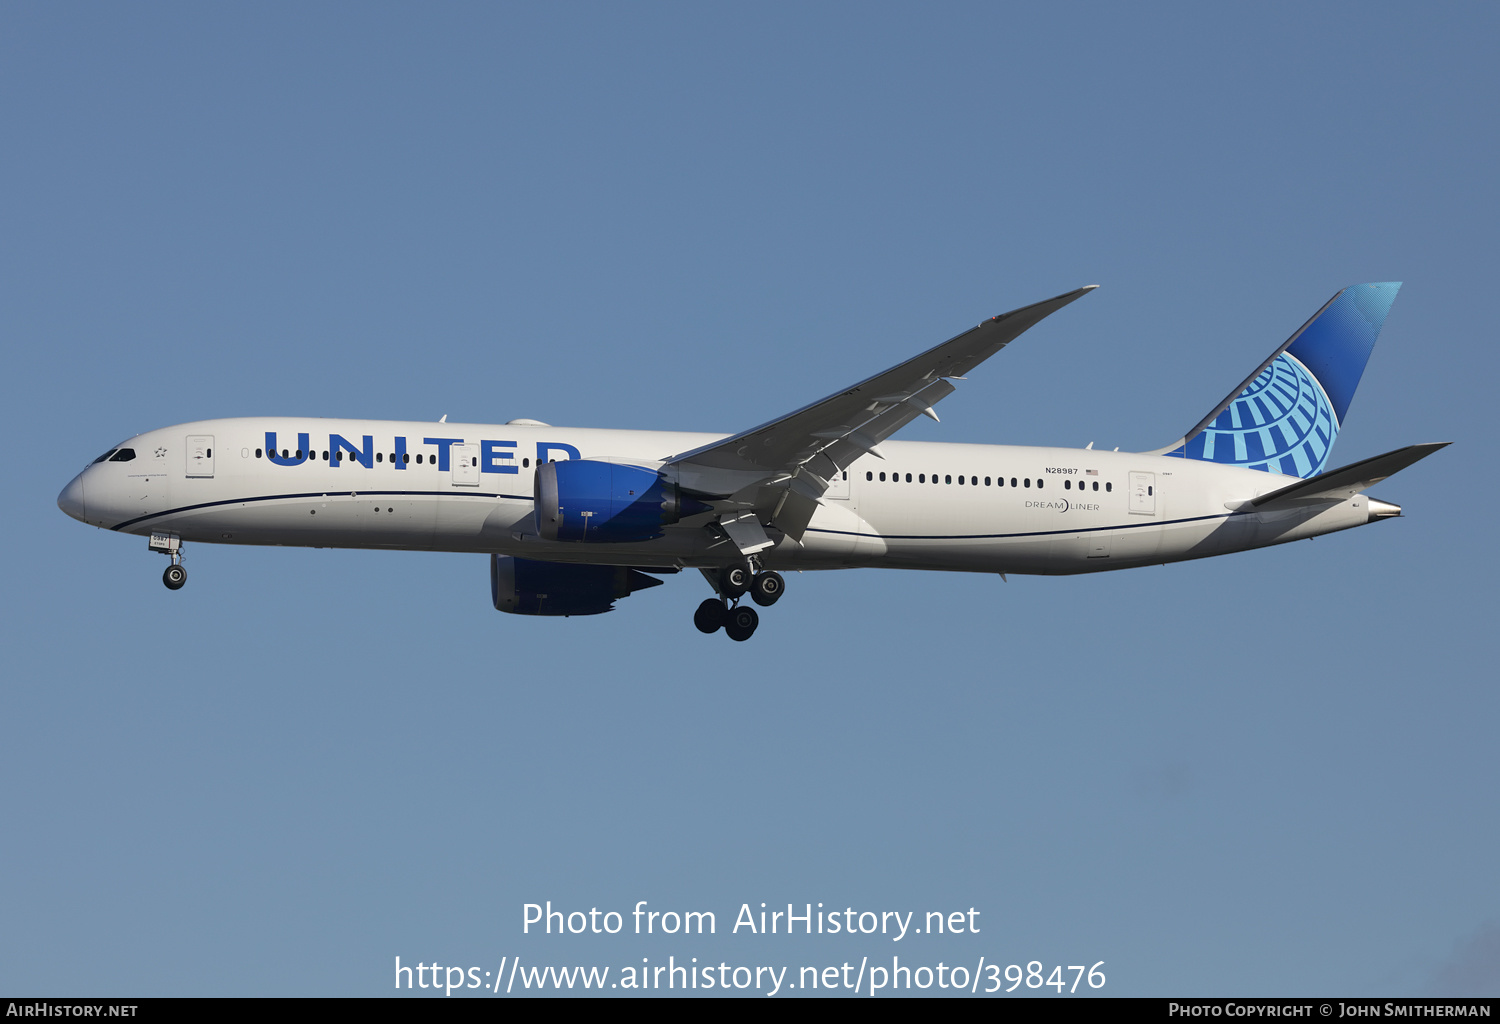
[0,4,1500,996]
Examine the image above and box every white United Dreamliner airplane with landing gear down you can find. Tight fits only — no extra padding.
[57,282,1446,640]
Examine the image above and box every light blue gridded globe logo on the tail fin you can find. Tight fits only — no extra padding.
[1170,352,1338,478]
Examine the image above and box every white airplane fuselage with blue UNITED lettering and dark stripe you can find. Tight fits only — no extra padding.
[60,417,1373,574]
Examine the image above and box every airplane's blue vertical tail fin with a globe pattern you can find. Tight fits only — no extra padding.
[1157,280,1401,478]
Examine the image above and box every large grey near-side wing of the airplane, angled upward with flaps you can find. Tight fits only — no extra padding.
[668,285,1095,550]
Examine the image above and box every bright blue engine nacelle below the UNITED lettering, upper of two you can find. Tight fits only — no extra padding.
[536,459,713,543]
